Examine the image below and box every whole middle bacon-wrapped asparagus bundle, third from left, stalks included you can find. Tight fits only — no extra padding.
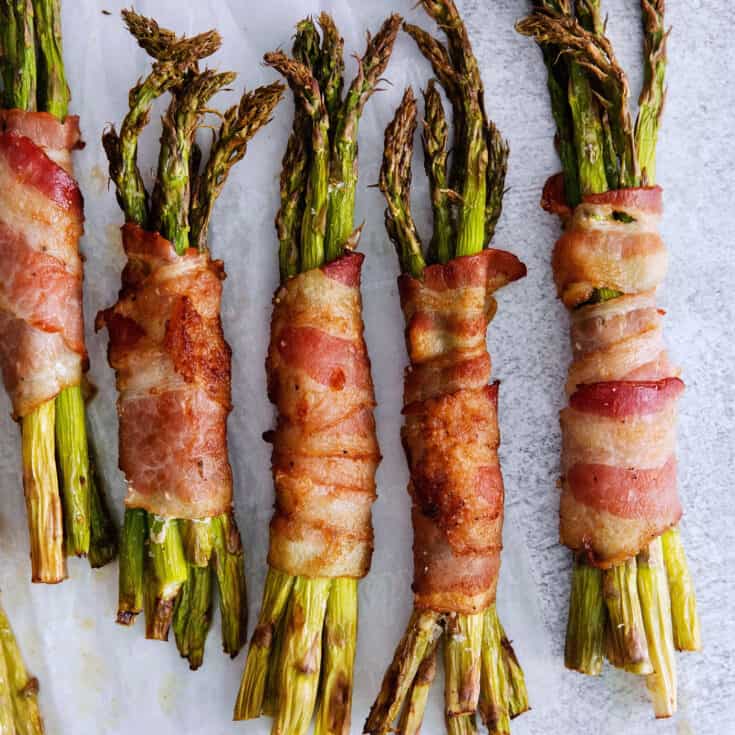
[234,13,400,735]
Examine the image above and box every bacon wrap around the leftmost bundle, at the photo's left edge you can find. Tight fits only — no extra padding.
[0,110,86,418]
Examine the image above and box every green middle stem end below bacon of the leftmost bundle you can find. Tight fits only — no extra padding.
[56,385,90,556]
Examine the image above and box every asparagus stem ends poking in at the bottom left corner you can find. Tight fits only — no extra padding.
[0,607,44,735]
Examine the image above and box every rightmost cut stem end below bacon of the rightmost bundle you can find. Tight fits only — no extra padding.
[661,527,702,651]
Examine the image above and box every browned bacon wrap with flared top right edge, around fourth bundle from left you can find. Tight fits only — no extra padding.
[398,250,526,614]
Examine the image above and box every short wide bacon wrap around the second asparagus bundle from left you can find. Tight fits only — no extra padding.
[96,224,232,519]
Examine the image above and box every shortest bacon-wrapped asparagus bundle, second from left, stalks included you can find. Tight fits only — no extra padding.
[97,11,284,669]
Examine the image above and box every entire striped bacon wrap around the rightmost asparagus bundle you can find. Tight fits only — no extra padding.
[542,178,684,568]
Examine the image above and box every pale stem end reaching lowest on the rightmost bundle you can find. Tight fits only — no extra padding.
[638,536,676,717]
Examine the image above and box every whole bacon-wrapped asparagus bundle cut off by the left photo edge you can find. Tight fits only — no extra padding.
[0,0,117,583]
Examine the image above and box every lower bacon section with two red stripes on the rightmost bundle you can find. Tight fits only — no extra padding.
[560,378,684,567]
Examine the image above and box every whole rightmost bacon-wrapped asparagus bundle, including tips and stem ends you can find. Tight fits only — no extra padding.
[518,0,700,717]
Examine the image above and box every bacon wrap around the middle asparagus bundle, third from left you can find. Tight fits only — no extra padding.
[266,253,380,578]
